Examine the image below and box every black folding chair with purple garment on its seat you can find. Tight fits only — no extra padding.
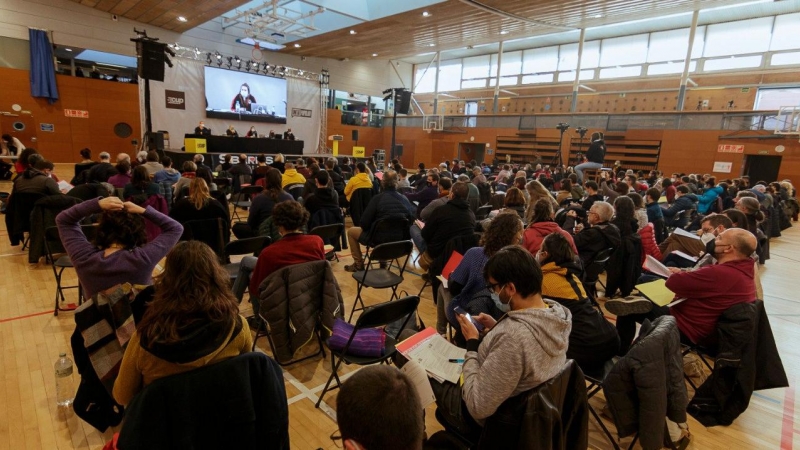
[315,296,419,408]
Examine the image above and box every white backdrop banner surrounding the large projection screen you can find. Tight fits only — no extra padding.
[139,58,320,154]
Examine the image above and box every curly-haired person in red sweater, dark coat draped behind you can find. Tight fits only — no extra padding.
[248,200,325,314]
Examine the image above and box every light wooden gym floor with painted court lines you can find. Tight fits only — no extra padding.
[0,168,800,450]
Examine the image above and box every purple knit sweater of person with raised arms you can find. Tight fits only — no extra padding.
[56,199,183,298]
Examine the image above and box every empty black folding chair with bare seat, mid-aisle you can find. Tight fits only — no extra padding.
[347,241,414,322]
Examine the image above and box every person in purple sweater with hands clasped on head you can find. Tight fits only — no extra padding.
[56,197,183,298]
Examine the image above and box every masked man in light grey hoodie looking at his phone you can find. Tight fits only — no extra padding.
[438,245,572,442]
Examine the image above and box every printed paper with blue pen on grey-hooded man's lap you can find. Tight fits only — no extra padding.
[396,327,467,383]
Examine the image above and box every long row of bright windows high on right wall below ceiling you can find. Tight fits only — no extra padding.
[414,13,800,93]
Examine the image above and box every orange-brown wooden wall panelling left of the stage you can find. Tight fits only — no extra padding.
[0,68,142,163]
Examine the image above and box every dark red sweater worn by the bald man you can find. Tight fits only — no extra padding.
[667,258,756,344]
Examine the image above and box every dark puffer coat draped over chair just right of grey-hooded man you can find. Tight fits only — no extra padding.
[603,316,688,450]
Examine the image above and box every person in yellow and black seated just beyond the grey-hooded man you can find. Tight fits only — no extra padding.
[535,233,619,372]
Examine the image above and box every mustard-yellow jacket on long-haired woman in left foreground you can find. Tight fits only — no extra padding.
[113,316,253,405]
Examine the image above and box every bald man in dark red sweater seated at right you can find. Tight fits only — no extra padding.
[606,228,756,351]
